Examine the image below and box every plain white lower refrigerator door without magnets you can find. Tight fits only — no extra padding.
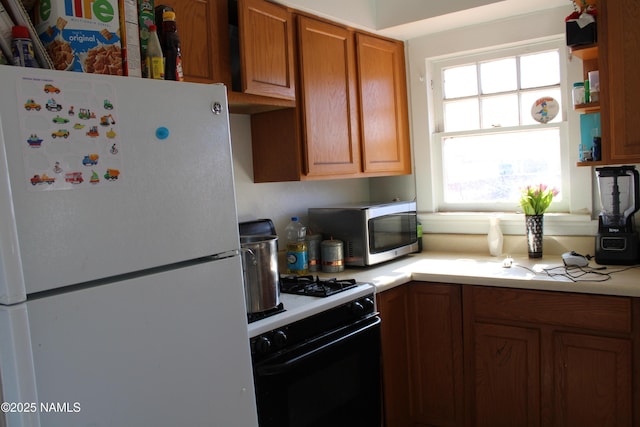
[0,256,257,427]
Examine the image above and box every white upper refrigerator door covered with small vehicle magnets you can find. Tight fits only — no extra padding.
[0,66,239,304]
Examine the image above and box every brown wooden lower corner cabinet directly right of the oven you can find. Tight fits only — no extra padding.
[378,282,464,427]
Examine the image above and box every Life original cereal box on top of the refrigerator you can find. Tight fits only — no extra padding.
[35,0,123,75]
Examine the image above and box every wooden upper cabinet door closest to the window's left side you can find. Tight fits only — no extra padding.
[356,34,411,175]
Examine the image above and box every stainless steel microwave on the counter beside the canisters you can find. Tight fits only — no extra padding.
[309,201,418,266]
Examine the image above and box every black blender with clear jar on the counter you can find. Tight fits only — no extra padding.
[595,166,640,265]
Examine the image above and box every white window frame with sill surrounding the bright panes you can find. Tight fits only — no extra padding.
[416,37,597,235]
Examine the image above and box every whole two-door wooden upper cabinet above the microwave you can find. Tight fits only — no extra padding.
[251,14,411,182]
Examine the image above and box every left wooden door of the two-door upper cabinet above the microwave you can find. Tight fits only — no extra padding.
[298,16,360,177]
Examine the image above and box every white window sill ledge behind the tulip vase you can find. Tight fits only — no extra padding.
[418,212,598,236]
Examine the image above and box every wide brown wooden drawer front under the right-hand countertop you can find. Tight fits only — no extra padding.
[465,286,631,333]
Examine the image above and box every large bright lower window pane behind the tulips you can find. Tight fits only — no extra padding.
[442,128,561,206]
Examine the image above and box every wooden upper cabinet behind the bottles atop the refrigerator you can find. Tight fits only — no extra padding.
[156,0,295,114]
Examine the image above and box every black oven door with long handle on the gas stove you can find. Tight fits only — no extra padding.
[254,316,381,427]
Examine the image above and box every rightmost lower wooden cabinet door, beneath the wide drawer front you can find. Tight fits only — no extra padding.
[554,332,633,427]
